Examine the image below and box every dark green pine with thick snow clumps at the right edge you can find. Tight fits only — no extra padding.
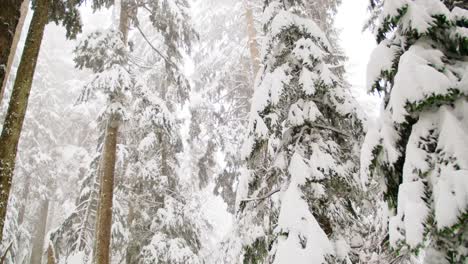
[362,0,468,263]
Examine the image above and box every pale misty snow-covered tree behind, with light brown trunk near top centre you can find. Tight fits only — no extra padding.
[191,0,260,213]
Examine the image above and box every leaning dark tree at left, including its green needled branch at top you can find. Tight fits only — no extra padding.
[0,0,85,239]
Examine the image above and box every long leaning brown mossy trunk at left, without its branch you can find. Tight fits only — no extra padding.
[0,0,50,240]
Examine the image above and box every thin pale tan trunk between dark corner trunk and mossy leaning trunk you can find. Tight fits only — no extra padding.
[0,0,29,106]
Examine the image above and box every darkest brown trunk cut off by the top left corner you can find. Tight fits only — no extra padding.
[0,0,23,101]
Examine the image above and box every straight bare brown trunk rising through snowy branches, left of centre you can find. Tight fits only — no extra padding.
[95,4,129,264]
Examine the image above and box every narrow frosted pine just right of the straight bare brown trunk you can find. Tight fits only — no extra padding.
[122,1,208,263]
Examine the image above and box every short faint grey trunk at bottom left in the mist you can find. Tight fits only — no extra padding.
[30,198,49,264]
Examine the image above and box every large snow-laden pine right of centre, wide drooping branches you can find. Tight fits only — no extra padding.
[232,1,362,263]
